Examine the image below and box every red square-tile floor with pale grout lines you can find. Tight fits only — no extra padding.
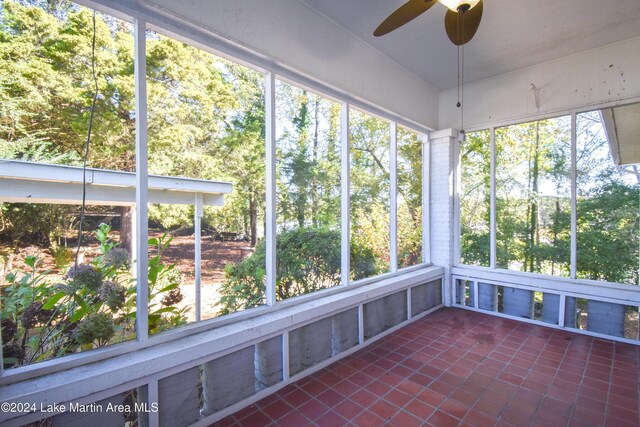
[214,308,640,427]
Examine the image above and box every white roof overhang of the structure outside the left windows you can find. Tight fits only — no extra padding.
[0,160,233,206]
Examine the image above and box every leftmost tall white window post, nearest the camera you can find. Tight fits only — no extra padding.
[134,19,149,341]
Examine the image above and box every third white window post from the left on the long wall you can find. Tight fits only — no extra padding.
[340,102,351,285]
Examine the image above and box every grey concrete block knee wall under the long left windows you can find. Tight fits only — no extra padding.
[36,279,442,427]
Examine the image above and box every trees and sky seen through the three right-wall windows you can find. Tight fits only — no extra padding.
[460,111,640,284]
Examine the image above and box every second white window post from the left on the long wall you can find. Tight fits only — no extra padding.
[264,72,276,305]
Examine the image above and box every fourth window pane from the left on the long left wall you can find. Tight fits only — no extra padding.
[349,109,390,280]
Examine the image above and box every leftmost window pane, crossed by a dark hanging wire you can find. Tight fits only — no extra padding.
[0,1,136,368]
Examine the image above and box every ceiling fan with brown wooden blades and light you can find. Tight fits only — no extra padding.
[373,0,482,46]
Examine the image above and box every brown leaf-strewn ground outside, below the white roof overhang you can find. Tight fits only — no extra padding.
[0,232,253,322]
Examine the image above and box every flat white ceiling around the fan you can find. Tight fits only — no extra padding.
[300,0,640,90]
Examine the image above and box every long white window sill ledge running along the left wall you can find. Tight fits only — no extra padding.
[0,267,444,423]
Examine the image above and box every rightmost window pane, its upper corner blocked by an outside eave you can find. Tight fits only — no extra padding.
[576,111,640,285]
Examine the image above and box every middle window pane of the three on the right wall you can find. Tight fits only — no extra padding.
[496,116,571,276]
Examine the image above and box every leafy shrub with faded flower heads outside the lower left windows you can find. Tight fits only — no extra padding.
[0,224,187,367]
